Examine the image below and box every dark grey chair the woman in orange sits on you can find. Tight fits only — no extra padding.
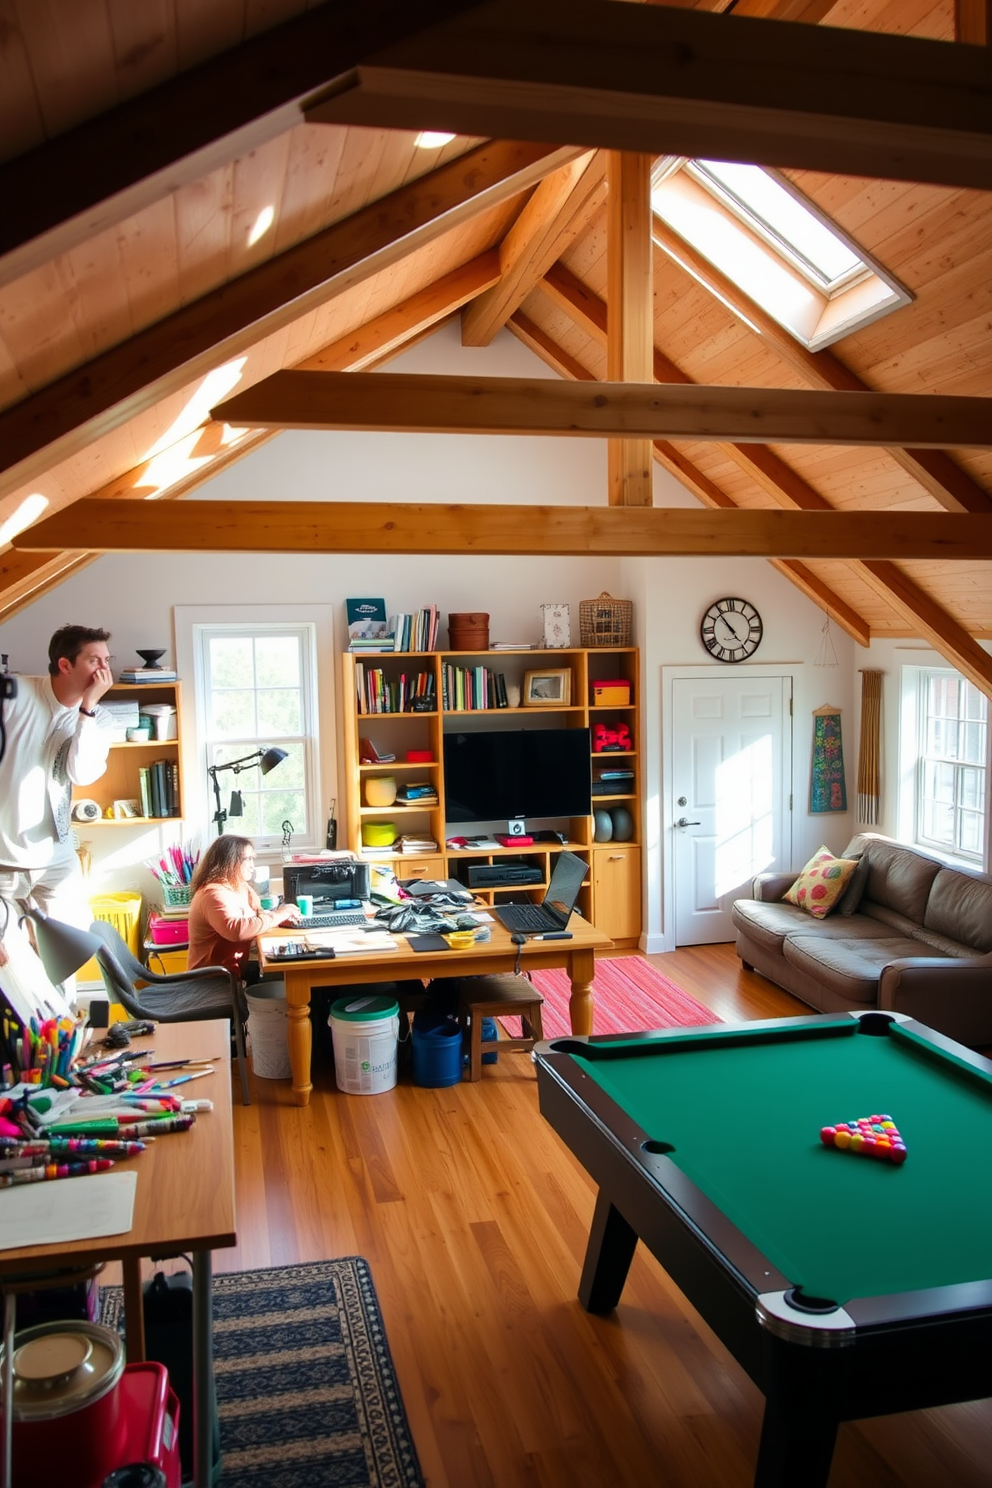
[89,920,251,1106]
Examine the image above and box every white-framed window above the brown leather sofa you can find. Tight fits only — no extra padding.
[913,668,989,863]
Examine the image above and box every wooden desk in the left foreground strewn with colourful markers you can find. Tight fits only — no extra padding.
[0,1018,238,1488]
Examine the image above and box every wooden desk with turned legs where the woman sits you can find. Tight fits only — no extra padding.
[259,915,613,1106]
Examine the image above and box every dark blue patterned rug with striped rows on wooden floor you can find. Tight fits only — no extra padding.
[101,1256,424,1488]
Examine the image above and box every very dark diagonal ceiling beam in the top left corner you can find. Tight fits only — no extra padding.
[0,0,484,284]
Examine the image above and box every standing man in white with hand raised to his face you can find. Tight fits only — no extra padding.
[0,625,113,930]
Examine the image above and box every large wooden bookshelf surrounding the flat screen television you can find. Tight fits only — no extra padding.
[344,646,642,945]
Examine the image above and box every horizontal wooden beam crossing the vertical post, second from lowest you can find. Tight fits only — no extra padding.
[211,372,992,448]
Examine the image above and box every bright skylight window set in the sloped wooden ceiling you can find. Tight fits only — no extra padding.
[651,158,912,351]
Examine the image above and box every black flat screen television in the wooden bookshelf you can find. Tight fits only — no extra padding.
[445,729,592,821]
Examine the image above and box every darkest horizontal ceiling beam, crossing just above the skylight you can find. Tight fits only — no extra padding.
[306,0,992,190]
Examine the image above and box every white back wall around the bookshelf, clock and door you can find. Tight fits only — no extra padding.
[0,326,864,949]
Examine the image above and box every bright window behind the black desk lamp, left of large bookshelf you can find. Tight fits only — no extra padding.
[193,623,318,848]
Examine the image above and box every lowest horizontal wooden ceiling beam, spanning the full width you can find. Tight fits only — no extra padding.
[13,500,992,562]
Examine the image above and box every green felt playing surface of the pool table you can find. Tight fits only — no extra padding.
[577,1019,992,1303]
